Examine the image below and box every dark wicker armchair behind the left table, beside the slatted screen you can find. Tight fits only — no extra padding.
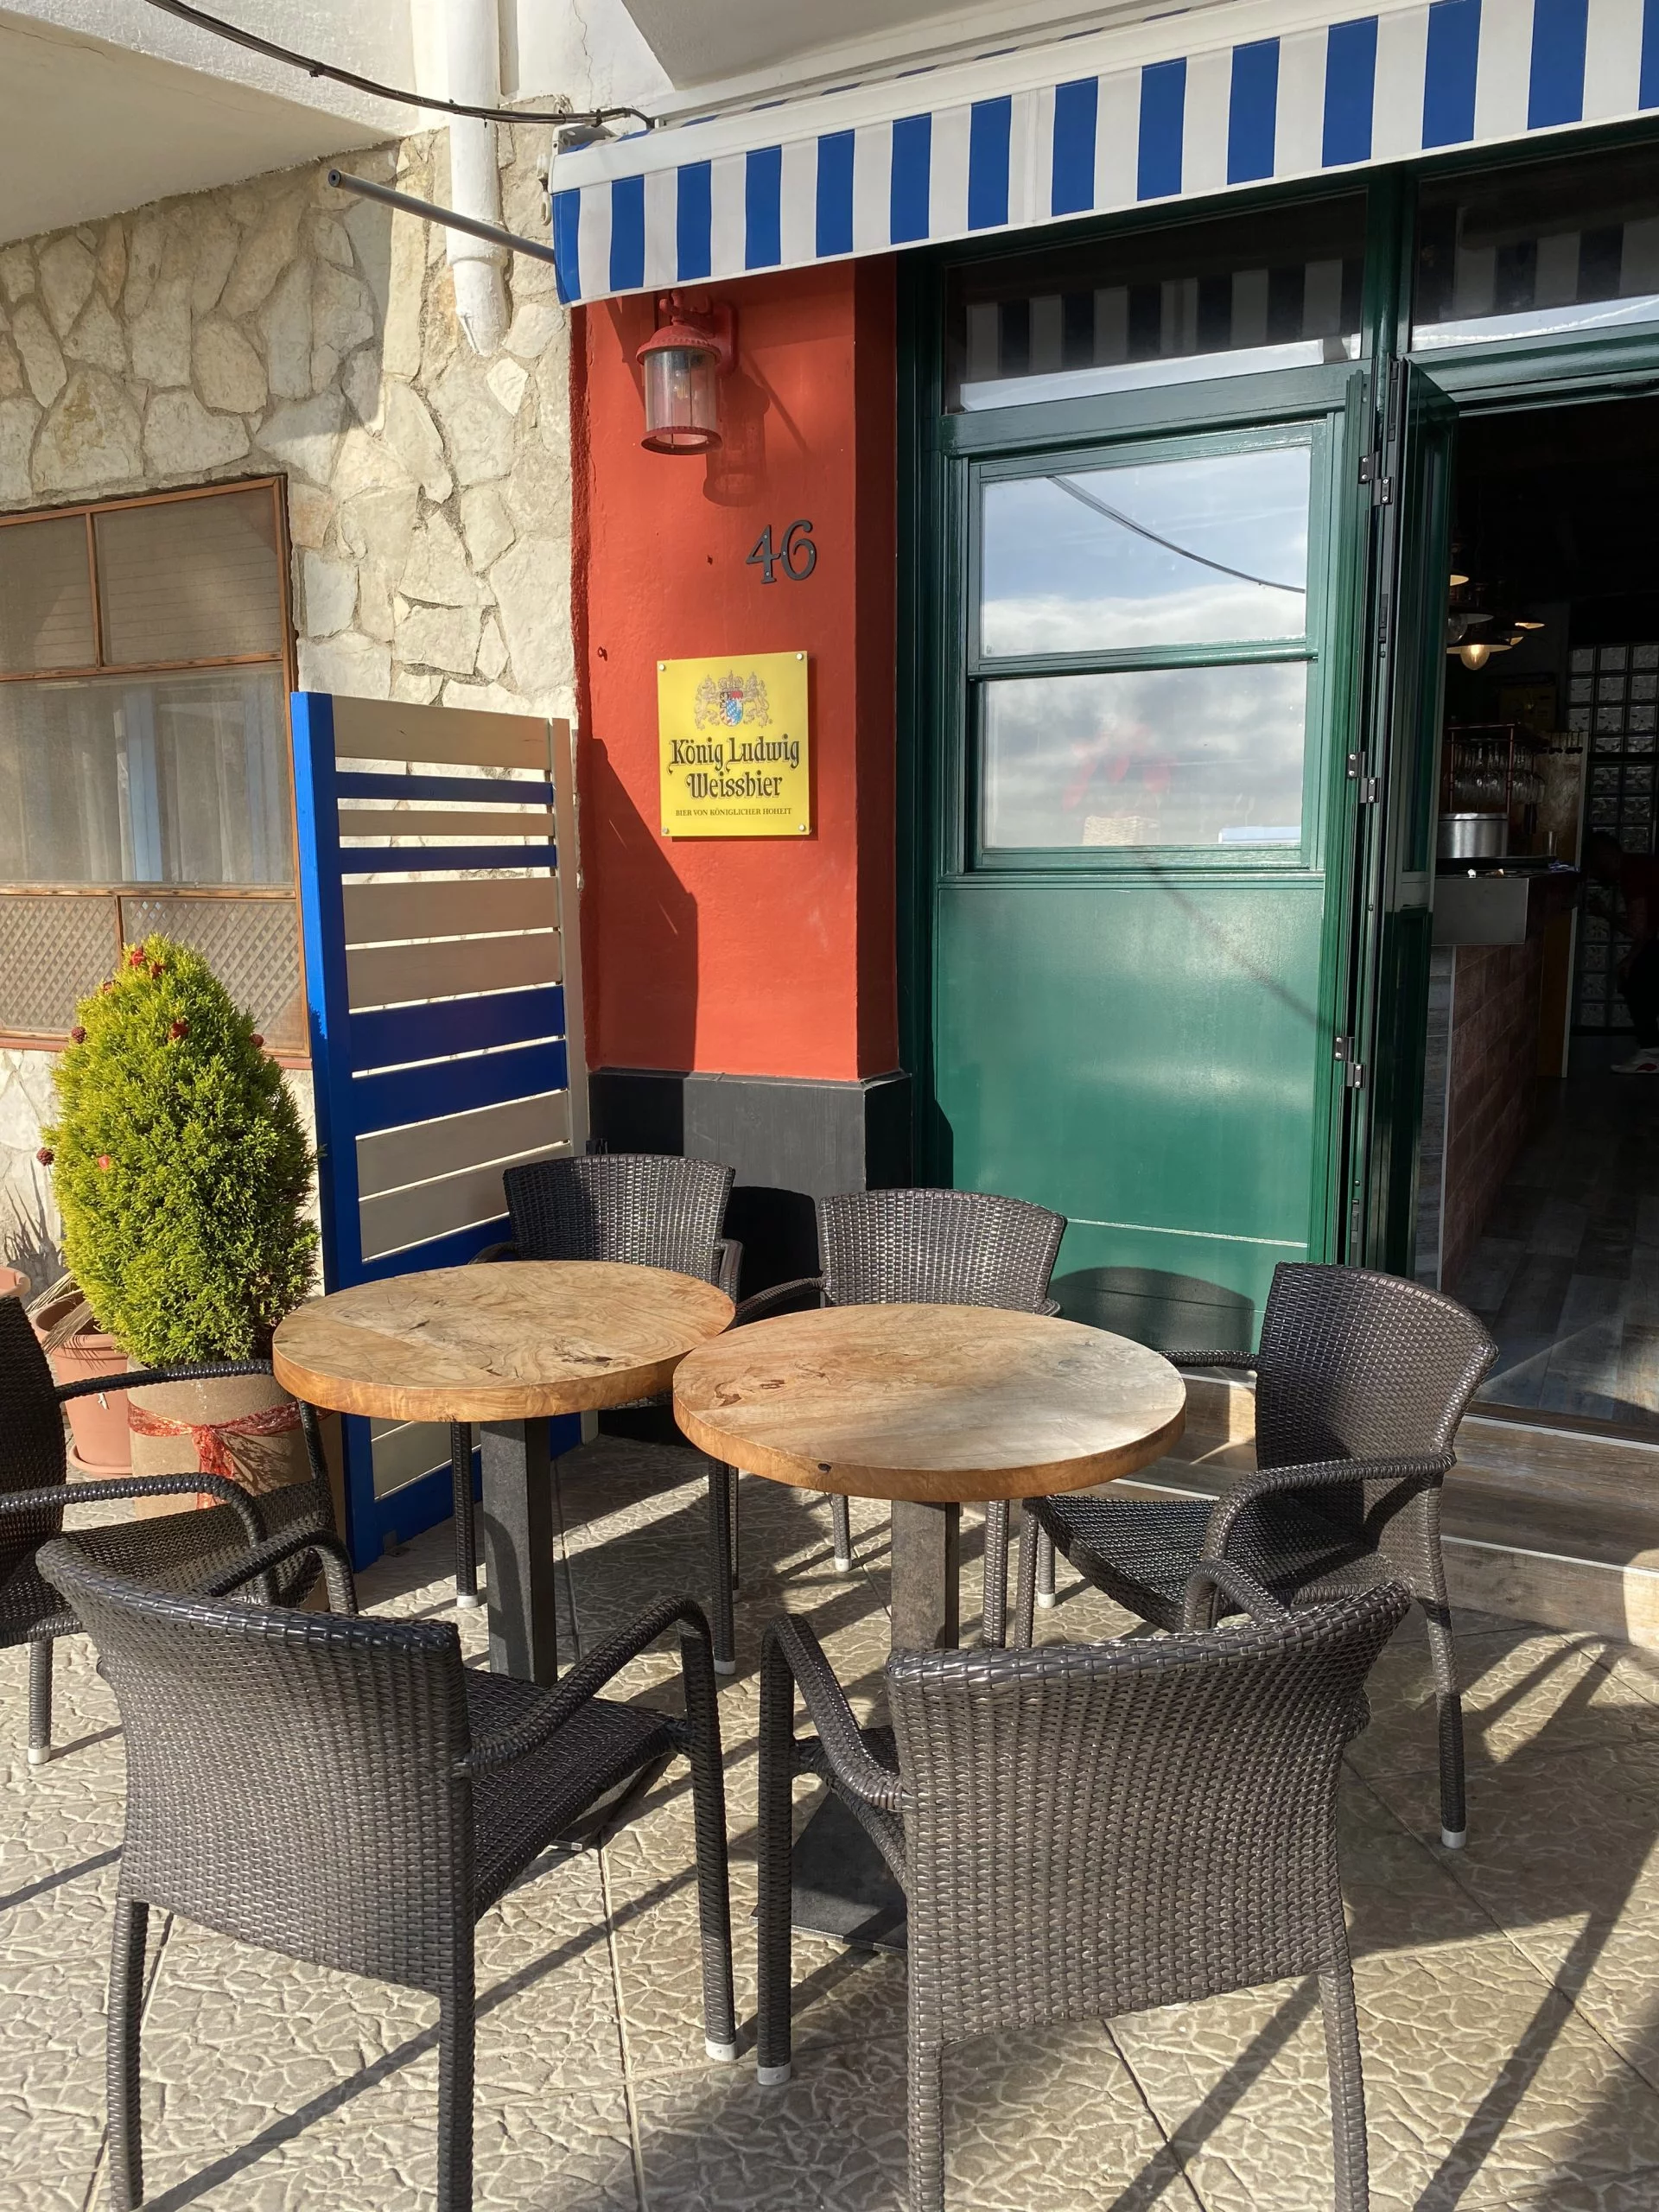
[449,1153,743,1618]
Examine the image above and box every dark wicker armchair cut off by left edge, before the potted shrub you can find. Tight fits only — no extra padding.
[0,1299,343,1767]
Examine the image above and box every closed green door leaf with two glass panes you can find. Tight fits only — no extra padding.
[923,393,1365,1344]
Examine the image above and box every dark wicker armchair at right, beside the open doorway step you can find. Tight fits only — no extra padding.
[1015,1263,1496,1849]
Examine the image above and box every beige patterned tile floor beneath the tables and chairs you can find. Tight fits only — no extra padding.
[0,1440,1659,2212]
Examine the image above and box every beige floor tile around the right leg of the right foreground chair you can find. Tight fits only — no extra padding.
[1110,1936,1659,2212]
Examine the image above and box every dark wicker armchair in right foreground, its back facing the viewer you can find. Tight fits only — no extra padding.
[757,1561,1411,2212]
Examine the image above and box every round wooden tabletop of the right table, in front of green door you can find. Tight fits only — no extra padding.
[675,1305,1185,1504]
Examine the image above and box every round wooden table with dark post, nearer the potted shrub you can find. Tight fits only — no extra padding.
[272,1259,732,1683]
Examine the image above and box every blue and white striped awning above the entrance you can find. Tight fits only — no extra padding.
[553,0,1659,301]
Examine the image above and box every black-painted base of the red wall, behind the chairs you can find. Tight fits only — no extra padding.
[588,1068,912,1294]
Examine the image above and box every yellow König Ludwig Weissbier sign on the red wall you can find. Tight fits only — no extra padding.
[657,652,812,836]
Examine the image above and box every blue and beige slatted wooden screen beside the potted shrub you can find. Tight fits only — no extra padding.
[292,692,582,1566]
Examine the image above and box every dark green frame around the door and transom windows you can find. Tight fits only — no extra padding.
[898,126,1659,1274]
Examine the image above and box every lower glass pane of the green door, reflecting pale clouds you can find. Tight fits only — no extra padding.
[984,661,1307,847]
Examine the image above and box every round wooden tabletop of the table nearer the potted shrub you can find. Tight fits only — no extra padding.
[272,1259,732,1421]
